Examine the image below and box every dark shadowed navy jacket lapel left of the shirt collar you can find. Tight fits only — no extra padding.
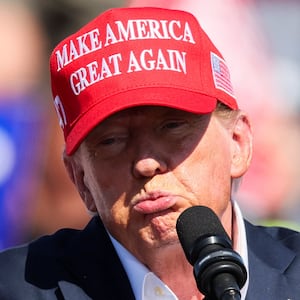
[60,217,135,300]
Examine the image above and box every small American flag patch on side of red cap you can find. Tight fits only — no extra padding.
[211,52,235,98]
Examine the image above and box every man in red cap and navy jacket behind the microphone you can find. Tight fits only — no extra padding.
[0,8,300,300]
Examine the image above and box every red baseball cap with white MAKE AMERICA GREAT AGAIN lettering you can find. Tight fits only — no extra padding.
[50,7,238,155]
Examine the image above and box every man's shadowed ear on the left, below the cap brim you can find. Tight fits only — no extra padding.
[63,151,97,213]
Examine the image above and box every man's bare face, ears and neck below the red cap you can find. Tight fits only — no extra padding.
[64,106,252,299]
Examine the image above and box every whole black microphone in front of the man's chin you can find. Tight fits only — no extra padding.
[176,206,247,300]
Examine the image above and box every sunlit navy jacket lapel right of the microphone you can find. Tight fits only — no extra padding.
[246,222,300,300]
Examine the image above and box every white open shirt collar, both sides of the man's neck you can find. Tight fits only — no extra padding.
[109,201,249,300]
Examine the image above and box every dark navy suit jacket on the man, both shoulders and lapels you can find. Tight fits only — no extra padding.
[0,217,300,300]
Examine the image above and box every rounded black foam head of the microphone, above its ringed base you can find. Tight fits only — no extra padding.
[176,206,231,264]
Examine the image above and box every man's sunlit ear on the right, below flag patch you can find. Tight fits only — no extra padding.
[231,112,253,178]
